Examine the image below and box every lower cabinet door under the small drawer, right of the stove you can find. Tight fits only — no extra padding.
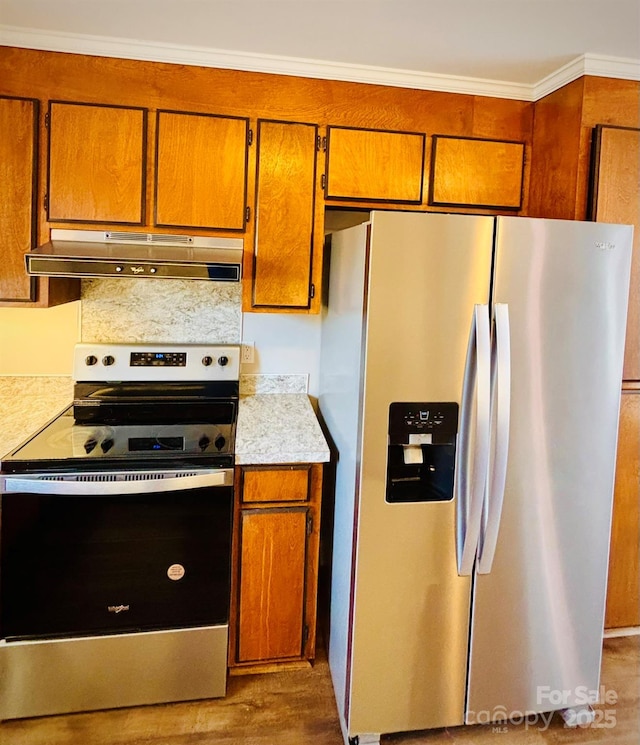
[238,507,308,662]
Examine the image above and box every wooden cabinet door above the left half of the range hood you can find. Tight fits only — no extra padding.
[47,101,147,225]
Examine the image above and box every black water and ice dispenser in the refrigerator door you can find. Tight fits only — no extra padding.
[386,402,458,502]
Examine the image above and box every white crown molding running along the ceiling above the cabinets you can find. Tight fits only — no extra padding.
[0,24,640,101]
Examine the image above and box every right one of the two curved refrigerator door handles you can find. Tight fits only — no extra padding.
[477,303,511,574]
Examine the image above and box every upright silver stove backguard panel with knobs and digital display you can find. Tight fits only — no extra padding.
[73,344,240,382]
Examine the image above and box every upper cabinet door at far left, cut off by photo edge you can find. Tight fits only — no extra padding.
[0,97,38,301]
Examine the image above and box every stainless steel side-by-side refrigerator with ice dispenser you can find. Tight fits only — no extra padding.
[319,212,632,745]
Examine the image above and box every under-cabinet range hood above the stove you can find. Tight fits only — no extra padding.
[25,230,244,282]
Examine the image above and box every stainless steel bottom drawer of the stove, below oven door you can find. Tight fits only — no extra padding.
[0,624,228,719]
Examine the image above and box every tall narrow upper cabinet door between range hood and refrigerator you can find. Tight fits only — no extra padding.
[251,120,323,309]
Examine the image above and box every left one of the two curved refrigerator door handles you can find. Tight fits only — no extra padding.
[456,305,491,576]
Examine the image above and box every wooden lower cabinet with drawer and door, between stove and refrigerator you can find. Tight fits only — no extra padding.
[229,464,322,673]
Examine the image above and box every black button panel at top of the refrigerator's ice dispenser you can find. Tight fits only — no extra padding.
[389,402,458,445]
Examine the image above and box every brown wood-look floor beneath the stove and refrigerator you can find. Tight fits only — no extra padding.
[0,636,640,745]
